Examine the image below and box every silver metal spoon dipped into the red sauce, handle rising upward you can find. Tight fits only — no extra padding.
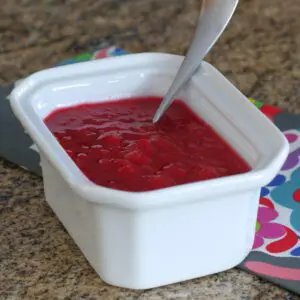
[153,0,238,123]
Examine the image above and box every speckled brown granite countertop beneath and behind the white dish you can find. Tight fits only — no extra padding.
[0,0,300,300]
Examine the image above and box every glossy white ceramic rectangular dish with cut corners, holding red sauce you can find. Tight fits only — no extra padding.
[10,53,288,289]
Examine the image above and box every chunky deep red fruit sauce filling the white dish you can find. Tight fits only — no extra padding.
[45,97,250,191]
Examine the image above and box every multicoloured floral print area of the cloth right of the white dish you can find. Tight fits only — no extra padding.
[253,129,300,257]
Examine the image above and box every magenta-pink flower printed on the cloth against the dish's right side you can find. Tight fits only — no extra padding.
[253,207,286,249]
